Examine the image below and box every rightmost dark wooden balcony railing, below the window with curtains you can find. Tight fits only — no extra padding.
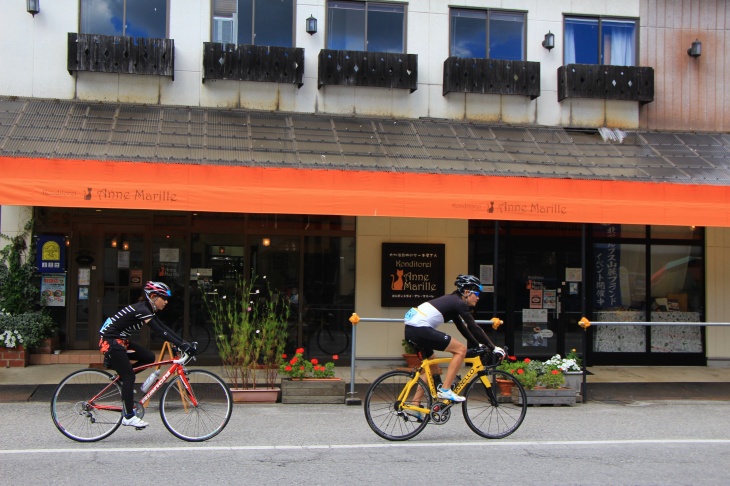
[558,64,654,104]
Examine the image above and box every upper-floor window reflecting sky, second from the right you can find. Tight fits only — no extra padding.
[449,8,525,61]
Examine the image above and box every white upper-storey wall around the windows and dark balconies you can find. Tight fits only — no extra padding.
[0,0,640,129]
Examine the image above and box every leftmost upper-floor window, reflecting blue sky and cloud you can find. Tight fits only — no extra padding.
[80,0,167,39]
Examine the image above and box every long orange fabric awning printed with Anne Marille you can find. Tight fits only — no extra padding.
[0,157,730,227]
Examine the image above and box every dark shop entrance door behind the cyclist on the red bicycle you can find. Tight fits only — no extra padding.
[67,223,149,349]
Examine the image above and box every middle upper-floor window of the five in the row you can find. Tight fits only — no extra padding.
[327,1,406,53]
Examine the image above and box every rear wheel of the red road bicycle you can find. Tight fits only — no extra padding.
[51,369,122,442]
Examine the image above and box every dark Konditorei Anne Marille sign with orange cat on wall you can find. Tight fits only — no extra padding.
[380,243,446,307]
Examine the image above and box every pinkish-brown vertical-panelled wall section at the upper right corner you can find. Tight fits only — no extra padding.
[639,0,730,132]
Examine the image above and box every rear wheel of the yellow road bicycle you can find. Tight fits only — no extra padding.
[365,371,431,440]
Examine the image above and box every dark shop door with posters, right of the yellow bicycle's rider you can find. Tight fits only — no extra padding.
[507,239,583,359]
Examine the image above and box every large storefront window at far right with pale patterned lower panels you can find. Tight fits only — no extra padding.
[591,225,705,353]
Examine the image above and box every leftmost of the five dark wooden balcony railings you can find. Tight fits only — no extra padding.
[67,32,175,81]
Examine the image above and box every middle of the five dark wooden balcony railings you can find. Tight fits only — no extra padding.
[318,49,418,93]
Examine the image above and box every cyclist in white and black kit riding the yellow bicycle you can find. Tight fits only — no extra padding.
[405,275,505,402]
